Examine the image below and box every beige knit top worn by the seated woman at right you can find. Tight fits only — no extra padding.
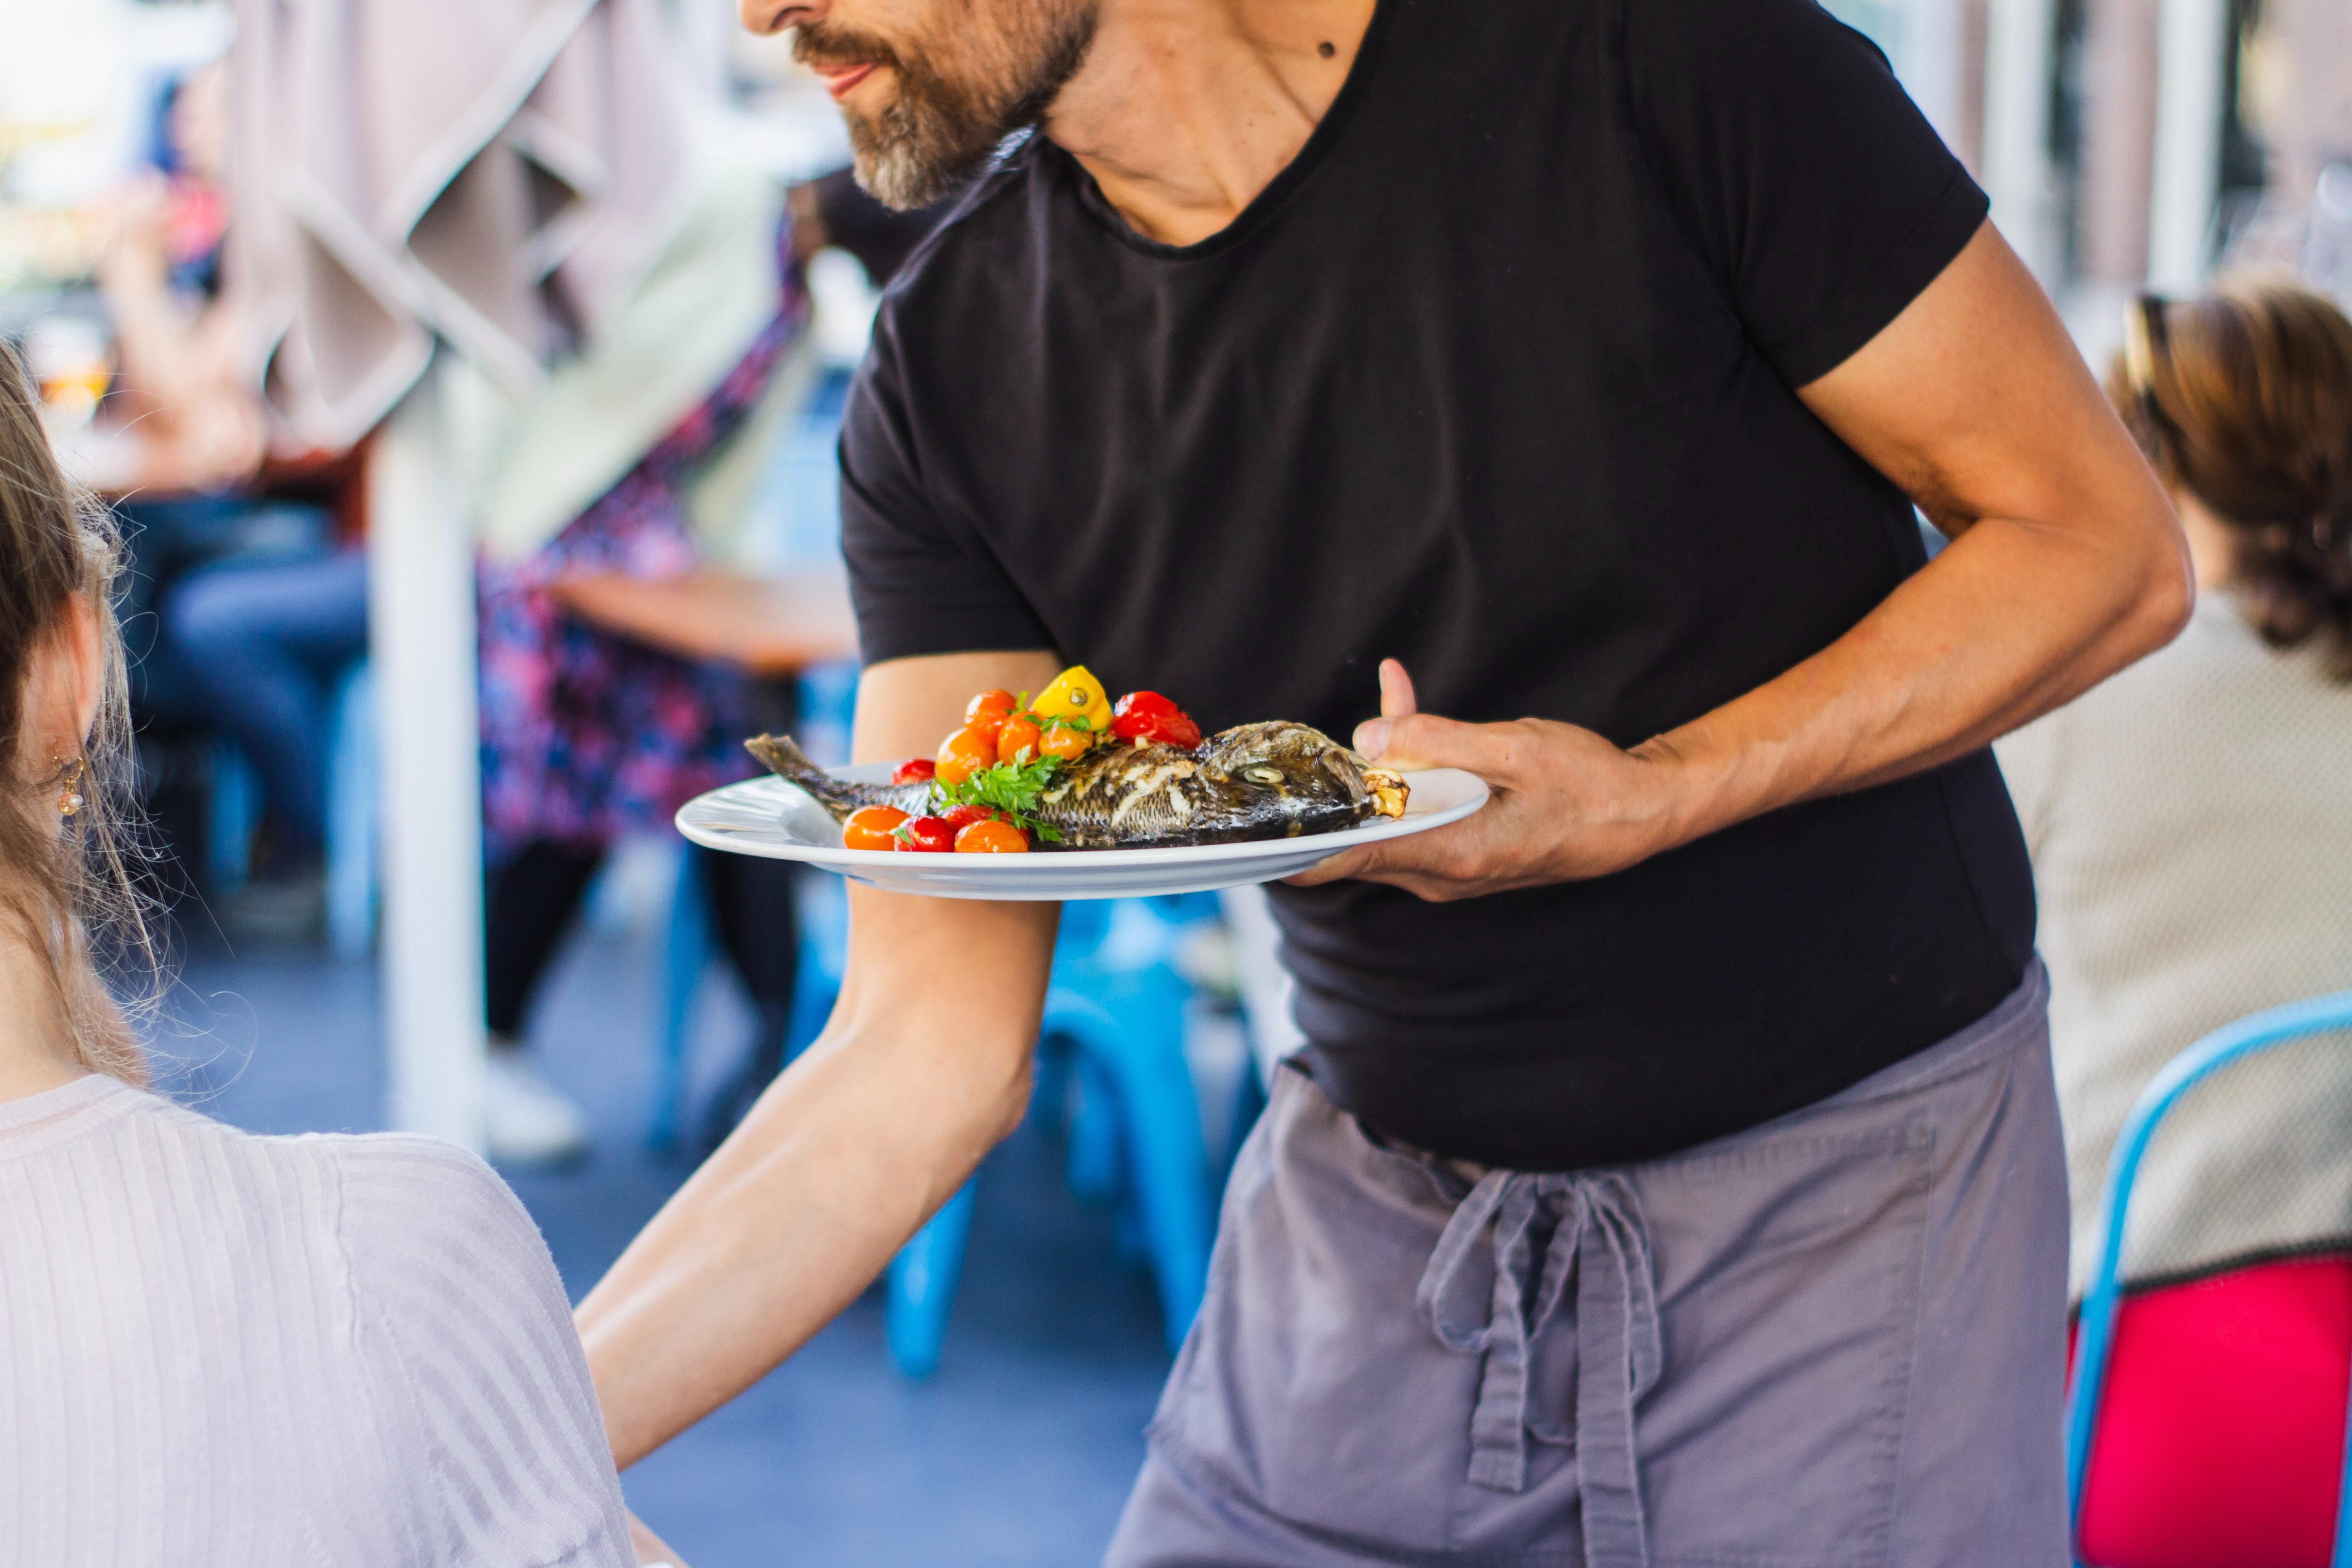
[1994,595,2352,1293]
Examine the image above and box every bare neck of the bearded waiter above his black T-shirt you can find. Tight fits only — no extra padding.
[1044,0,1373,245]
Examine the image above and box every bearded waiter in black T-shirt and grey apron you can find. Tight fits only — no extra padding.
[581,0,2192,1568]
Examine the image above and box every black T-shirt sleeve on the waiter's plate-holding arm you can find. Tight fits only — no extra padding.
[1621,0,1987,386]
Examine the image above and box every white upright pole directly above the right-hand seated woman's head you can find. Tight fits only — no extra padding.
[2147,0,2230,294]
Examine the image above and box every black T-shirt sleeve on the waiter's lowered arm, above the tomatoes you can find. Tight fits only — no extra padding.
[842,301,1054,665]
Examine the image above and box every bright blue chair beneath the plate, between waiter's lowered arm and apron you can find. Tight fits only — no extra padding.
[884,898,1216,1377]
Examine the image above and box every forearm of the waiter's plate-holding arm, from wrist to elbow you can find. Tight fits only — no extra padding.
[1635,500,2190,844]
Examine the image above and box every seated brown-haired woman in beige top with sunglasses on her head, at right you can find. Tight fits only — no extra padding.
[1994,282,2352,1295]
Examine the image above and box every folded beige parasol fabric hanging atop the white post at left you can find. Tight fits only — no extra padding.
[233,0,696,446]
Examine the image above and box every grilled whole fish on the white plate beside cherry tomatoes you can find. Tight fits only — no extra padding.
[743,720,1409,848]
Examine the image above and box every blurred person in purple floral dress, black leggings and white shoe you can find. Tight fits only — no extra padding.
[480,176,938,1164]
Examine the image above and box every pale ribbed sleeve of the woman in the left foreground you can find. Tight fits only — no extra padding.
[334,1133,637,1568]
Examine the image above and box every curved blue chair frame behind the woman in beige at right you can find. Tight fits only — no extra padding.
[2065,992,2352,1568]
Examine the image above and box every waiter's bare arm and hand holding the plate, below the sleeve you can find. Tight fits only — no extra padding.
[1301,223,2195,898]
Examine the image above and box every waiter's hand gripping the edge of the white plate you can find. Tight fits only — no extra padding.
[1291,658,1682,903]
